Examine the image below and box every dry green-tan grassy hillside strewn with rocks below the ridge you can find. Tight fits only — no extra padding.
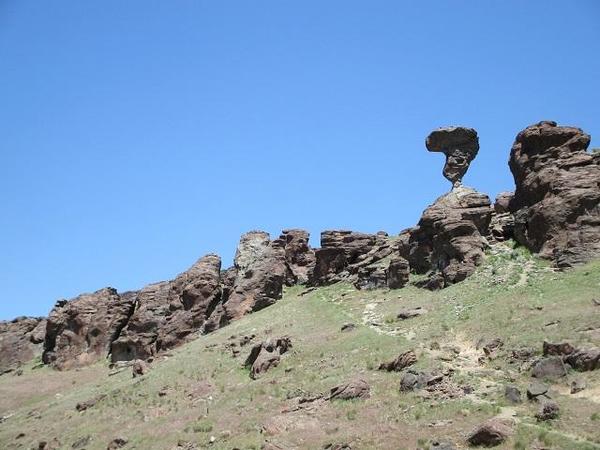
[0,244,600,450]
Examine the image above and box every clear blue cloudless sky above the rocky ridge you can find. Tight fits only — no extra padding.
[0,0,600,319]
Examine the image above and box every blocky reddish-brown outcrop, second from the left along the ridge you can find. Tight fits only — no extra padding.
[43,288,135,369]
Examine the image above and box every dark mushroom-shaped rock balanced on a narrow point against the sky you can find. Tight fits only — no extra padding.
[425,127,479,185]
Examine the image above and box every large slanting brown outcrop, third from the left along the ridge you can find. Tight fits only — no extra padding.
[111,254,221,362]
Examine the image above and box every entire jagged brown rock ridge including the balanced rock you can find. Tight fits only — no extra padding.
[0,122,600,373]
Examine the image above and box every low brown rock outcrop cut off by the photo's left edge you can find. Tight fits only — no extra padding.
[0,317,46,374]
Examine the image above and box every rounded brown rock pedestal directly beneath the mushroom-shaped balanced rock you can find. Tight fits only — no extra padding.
[408,186,493,289]
